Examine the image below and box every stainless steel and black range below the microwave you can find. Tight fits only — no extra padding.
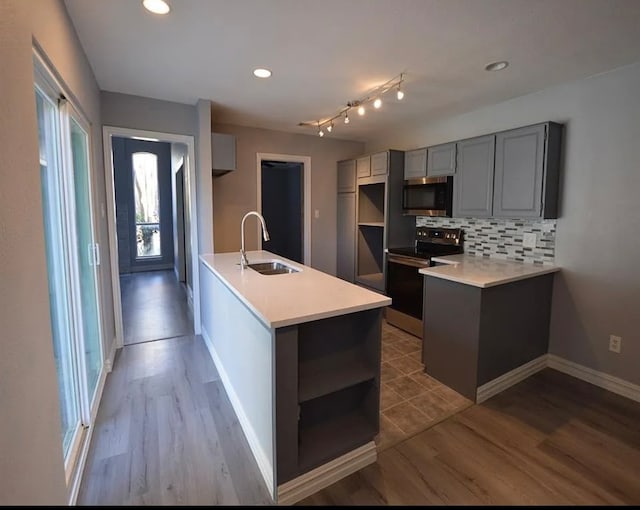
[386,227,463,338]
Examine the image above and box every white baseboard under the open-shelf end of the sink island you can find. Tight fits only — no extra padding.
[278,441,378,505]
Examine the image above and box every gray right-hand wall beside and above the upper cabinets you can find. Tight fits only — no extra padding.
[367,60,640,384]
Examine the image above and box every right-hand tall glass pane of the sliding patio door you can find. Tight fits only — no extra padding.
[69,117,102,402]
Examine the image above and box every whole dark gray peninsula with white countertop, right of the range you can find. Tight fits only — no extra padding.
[420,254,559,403]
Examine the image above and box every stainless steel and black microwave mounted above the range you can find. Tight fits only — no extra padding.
[402,176,453,216]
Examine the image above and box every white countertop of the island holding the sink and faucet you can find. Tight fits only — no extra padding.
[200,251,391,328]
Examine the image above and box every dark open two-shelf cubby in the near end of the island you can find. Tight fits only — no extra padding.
[276,308,382,484]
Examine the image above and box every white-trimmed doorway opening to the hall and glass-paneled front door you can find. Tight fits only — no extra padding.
[103,126,200,348]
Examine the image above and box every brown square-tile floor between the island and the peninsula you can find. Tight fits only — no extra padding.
[376,321,473,451]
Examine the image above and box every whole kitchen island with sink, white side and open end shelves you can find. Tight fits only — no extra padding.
[200,251,391,504]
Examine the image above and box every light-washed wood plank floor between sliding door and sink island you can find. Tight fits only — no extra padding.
[78,336,272,505]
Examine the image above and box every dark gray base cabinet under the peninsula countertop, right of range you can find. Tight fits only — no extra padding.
[422,274,554,402]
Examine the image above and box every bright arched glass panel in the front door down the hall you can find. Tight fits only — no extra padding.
[131,152,162,259]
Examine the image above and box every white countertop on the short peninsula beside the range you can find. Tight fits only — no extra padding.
[420,254,560,288]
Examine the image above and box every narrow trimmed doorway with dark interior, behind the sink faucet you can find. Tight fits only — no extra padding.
[256,153,311,266]
